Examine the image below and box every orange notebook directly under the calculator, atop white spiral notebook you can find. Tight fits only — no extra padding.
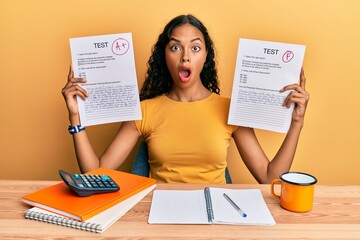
[22,168,156,221]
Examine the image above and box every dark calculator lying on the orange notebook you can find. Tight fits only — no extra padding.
[59,169,120,197]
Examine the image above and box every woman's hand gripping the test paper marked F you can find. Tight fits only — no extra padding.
[280,68,310,125]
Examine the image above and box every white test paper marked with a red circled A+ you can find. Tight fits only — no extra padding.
[70,33,141,126]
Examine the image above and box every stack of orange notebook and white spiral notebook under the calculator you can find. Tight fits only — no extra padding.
[22,168,156,233]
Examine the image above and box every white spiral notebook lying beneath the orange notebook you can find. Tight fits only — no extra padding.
[24,185,156,233]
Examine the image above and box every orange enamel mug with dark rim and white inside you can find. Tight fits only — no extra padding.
[270,172,317,212]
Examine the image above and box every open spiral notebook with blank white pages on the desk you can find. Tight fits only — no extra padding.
[148,188,275,225]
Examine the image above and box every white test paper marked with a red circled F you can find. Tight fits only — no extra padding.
[228,39,305,133]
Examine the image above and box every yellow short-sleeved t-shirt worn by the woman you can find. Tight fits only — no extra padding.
[135,93,237,183]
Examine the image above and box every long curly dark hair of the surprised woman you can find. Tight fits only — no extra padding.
[140,14,220,100]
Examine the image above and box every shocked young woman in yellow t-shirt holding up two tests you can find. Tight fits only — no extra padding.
[62,15,309,183]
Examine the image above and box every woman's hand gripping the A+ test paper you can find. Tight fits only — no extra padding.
[61,66,88,124]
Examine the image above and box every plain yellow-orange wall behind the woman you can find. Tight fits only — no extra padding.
[0,0,360,184]
